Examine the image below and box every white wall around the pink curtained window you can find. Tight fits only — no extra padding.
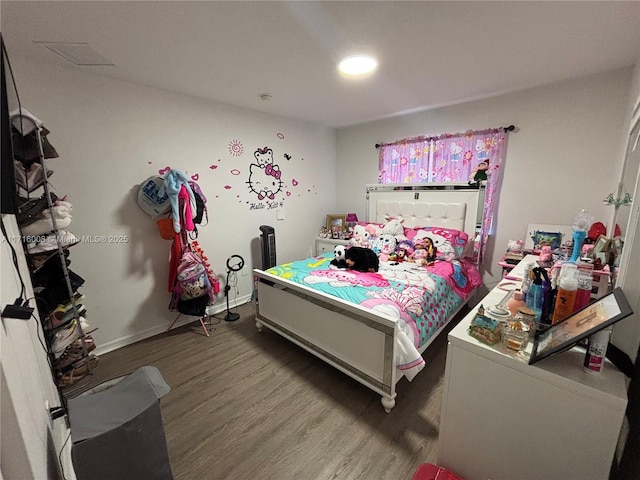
[336,69,631,288]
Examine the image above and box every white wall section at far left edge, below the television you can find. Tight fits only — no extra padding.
[0,214,75,480]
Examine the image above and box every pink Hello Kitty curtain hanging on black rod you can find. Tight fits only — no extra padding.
[378,128,507,257]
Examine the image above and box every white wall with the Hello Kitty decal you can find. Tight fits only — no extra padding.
[11,58,336,353]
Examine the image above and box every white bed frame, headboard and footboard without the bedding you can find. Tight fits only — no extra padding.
[253,184,484,413]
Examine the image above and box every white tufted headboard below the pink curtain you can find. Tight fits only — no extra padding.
[366,183,484,238]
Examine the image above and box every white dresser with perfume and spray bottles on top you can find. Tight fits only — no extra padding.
[438,257,627,480]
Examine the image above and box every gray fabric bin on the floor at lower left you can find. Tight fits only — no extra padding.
[67,366,173,480]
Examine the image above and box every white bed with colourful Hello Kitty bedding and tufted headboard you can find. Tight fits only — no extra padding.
[254,184,484,413]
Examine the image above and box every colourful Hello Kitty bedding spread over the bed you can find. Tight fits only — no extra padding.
[267,242,482,380]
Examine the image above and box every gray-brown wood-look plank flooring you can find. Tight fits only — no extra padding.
[65,303,466,480]
